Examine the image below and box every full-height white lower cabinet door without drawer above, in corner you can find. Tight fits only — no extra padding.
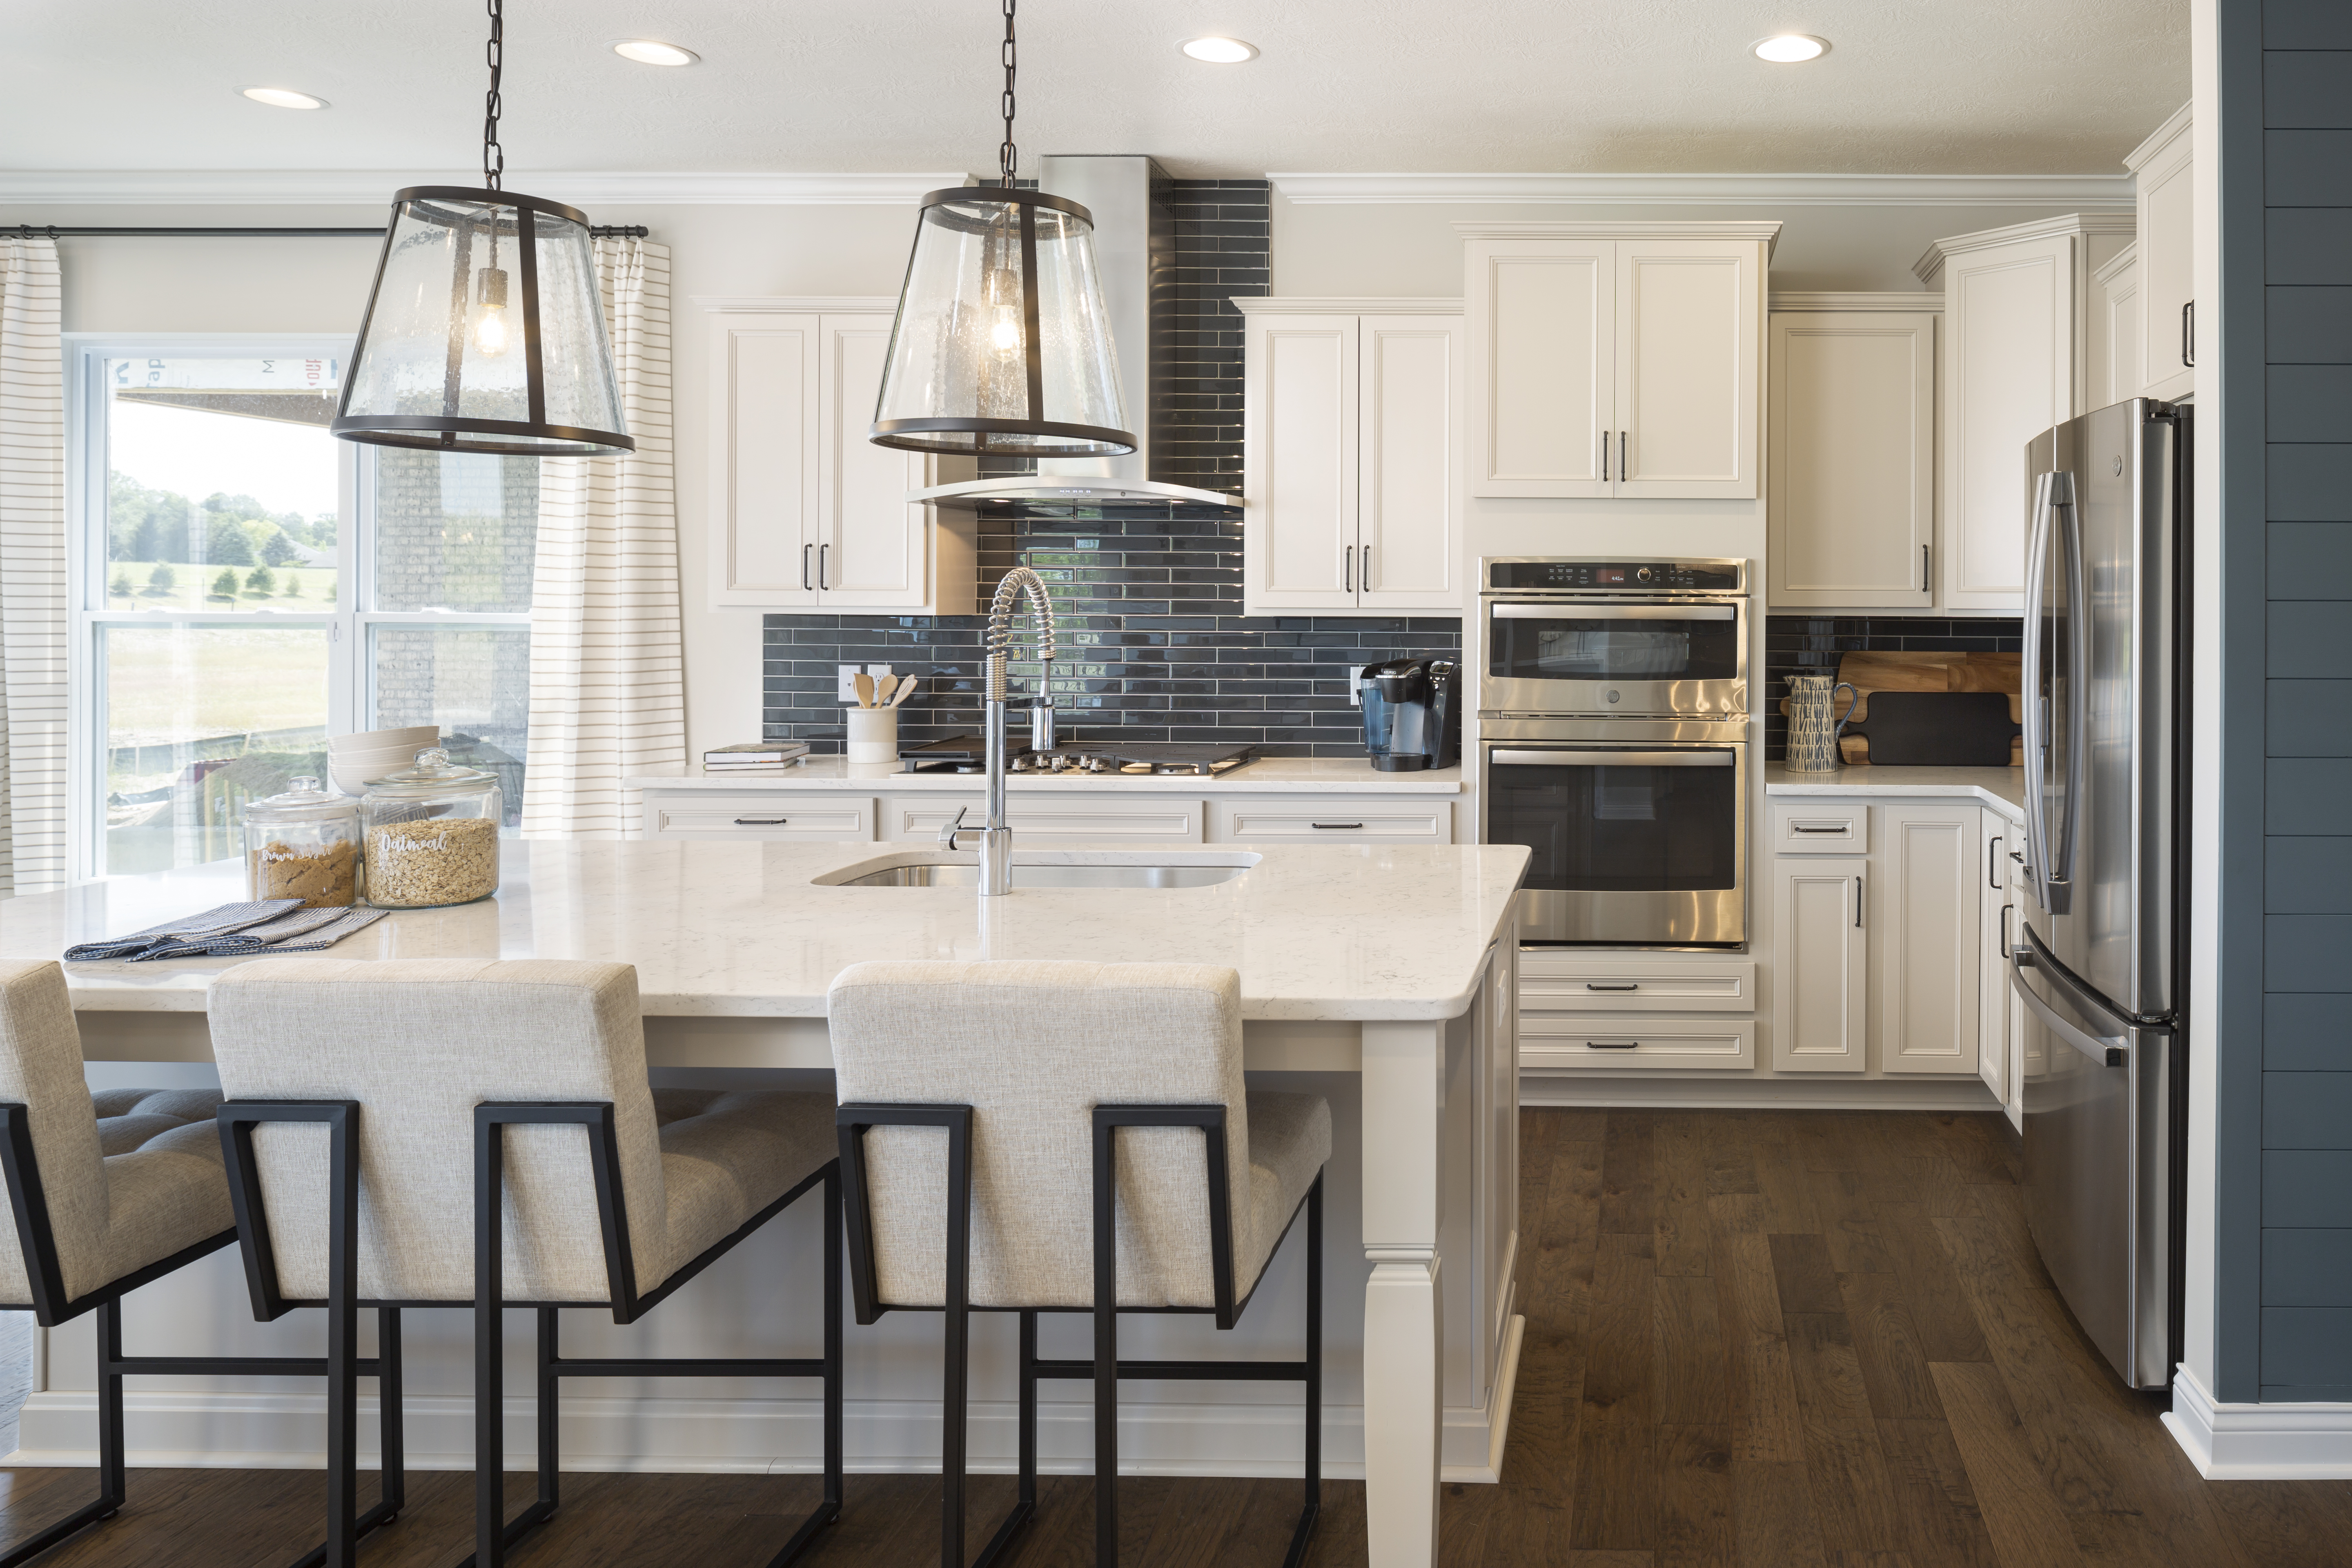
[1872,804,1985,1072]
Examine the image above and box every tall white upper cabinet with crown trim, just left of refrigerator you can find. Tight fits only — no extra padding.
[1912,214,2133,614]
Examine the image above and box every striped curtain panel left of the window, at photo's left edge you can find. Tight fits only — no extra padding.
[0,237,66,898]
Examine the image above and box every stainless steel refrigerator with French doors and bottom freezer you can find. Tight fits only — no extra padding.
[2009,397,2190,1387]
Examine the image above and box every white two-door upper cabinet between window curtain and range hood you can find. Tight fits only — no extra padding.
[710,301,978,616]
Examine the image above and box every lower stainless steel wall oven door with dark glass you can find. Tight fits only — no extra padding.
[1482,743,1748,947]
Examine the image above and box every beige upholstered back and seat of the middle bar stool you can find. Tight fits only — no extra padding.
[212,957,833,1302]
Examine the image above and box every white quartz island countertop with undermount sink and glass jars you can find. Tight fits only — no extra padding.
[13,839,1526,1020]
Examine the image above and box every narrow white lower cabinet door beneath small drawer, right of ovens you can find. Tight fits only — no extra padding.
[1771,856,1870,1072]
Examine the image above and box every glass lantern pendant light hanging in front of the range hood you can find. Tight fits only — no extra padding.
[873,0,1136,459]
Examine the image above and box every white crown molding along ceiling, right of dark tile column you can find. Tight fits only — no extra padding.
[1265,174,2136,212]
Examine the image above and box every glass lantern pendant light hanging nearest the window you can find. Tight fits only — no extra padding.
[327,0,637,459]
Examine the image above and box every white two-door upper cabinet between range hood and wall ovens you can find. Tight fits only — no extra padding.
[1235,298,1463,616]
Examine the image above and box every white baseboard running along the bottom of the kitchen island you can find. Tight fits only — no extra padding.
[0,1382,1524,1481]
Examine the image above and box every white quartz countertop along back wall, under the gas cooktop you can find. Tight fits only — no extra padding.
[623,757,1463,795]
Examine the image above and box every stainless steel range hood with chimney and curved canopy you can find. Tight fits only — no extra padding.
[908,158,1240,508]
